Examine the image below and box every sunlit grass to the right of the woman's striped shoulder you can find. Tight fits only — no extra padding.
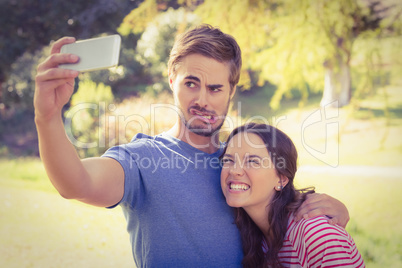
[296,173,402,268]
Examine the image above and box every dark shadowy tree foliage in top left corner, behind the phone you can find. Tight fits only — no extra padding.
[0,0,140,109]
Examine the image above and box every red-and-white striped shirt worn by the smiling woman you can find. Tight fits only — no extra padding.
[270,215,365,268]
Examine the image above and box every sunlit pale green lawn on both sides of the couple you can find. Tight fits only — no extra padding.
[0,159,402,267]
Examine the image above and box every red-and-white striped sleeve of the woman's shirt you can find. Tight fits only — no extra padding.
[301,217,365,267]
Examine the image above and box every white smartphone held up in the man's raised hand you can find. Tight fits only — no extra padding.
[59,34,121,72]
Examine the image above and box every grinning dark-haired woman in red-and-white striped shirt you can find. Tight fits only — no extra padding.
[221,124,364,267]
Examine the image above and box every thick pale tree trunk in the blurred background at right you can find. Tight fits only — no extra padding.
[320,63,351,108]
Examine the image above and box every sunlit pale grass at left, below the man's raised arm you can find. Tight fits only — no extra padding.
[0,158,134,268]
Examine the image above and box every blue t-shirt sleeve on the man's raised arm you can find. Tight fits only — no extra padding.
[102,145,142,208]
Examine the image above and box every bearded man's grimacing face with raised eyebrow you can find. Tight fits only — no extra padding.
[169,54,235,137]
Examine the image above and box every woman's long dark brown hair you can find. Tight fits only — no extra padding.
[223,123,314,268]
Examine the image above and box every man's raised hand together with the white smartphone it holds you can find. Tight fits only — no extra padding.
[34,35,121,123]
